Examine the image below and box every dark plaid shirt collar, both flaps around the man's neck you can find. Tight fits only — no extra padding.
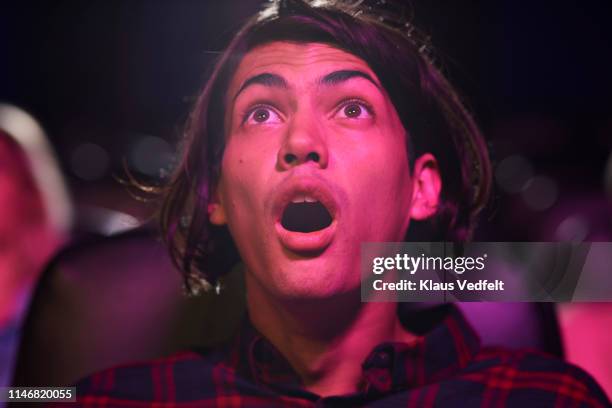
[230,305,480,393]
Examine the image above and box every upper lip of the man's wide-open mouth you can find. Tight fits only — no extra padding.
[272,177,338,226]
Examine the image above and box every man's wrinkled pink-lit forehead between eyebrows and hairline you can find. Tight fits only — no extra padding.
[229,41,380,95]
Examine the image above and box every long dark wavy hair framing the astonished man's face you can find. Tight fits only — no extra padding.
[160,0,491,293]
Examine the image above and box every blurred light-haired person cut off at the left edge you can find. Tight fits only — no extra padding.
[0,105,71,392]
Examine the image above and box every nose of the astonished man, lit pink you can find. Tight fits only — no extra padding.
[277,114,329,170]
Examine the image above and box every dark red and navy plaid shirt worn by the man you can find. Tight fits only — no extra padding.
[50,307,611,408]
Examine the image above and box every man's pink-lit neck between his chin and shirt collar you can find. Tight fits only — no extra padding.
[247,278,415,396]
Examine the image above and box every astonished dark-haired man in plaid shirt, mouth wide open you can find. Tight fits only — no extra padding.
[65,0,609,407]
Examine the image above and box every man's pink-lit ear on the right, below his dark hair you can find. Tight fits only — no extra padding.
[410,153,442,220]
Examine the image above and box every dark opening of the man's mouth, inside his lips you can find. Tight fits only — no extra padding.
[281,197,333,233]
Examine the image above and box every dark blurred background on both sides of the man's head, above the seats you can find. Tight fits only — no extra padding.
[0,0,612,241]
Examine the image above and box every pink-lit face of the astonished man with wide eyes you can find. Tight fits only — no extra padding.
[209,42,438,299]
